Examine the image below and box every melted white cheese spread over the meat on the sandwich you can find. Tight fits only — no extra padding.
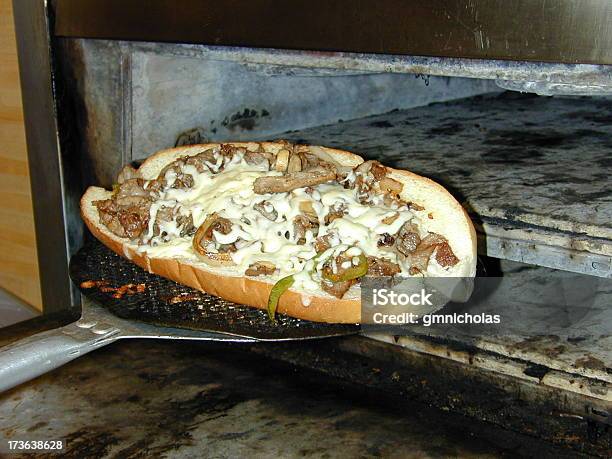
[138,154,432,291]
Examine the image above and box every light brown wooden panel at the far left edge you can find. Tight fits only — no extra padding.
[0,0,42,309]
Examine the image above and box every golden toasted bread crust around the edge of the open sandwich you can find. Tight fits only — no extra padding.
[81,142,476,323]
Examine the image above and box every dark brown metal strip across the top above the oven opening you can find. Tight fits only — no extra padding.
[55,0,612,64]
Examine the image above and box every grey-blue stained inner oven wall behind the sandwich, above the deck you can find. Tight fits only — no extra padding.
[58,39,499,190]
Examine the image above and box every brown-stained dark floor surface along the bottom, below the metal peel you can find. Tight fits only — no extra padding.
[0,340,579,458]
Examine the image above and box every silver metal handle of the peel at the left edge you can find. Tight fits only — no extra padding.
[0,322,120,392]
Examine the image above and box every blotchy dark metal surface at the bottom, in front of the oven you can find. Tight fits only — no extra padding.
[0,340,596,459]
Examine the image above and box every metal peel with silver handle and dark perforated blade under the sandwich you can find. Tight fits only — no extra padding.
[0,241,359,392]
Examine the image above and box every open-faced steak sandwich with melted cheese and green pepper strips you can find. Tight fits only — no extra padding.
[81,142,476,323]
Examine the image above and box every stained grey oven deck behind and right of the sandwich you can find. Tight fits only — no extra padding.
[283,93,612,277]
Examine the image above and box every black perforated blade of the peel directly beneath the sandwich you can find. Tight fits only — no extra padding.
[70,241,359,340]
